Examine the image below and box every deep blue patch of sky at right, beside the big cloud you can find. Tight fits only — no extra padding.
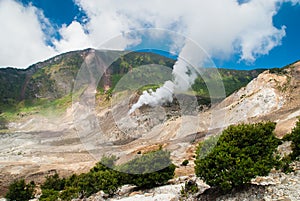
[214,3,300,69]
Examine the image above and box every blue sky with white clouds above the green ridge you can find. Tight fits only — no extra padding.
[0,0,300,69]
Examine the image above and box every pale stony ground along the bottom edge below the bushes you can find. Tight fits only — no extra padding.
[18,162,300,201]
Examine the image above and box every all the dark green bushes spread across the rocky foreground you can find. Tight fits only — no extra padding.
[6,120,300,201]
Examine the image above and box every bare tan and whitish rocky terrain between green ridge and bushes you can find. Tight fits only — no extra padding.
[0,62,300,200]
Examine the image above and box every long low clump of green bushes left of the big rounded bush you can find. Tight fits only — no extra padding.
[41,149,175,201]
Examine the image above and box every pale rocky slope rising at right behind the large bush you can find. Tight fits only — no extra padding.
[206,61,300,136]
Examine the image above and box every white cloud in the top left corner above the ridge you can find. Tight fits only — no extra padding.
[0,0,55,68]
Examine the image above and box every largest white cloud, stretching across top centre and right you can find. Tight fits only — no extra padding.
[72,0,299,62]
